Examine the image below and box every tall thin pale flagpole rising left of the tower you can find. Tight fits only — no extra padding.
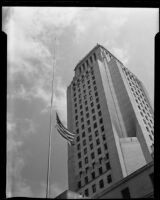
[46,38,56,198]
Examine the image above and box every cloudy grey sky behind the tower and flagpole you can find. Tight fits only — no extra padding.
[2,7,159,198]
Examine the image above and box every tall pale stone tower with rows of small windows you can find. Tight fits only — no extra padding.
[67,44,154,197]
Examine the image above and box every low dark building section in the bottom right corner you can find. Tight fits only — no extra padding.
[93,161,154,199]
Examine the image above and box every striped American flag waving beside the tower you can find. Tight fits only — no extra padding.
[56,113,75,145]
